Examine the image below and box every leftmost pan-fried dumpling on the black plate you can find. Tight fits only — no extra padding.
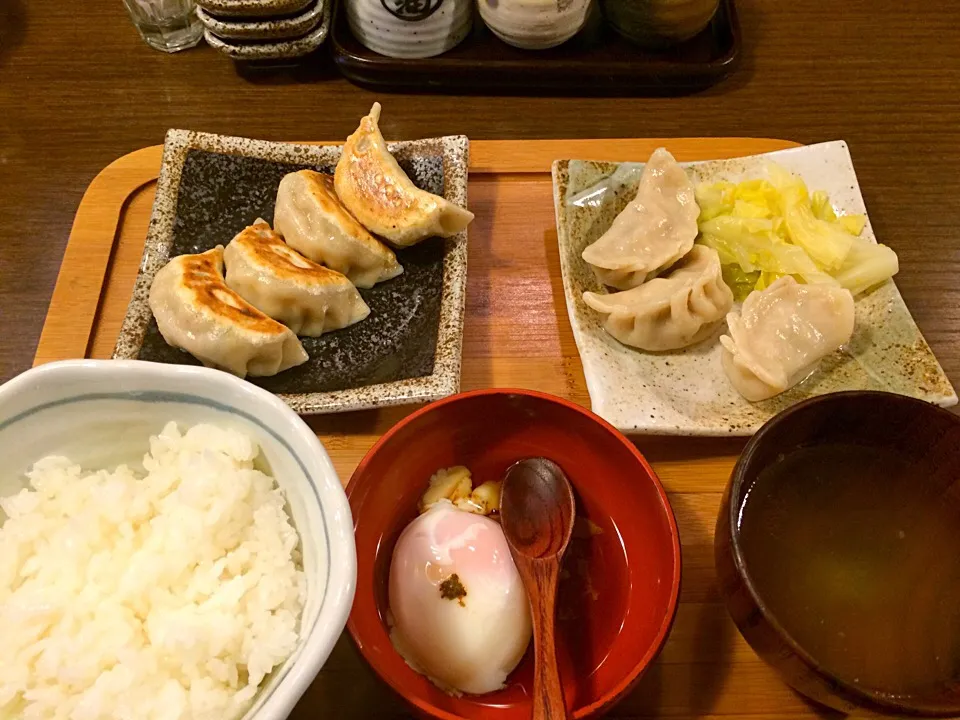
[149,245,307,377]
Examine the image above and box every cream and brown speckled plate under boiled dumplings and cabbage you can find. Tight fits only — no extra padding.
[553,142,957,435]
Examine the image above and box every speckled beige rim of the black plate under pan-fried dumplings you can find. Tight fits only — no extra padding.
[113,129,469,415]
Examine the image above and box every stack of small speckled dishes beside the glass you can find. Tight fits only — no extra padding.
[197,0,332,61]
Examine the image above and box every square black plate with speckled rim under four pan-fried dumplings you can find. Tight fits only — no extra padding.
[114,130,469,414]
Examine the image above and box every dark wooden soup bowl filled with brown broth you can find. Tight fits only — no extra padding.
[715,392,960,717]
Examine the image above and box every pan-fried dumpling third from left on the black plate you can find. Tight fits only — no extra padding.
[273,170,403,288]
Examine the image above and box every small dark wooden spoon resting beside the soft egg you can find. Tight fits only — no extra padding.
[500,458,576,720]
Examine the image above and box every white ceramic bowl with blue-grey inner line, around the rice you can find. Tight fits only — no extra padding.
[0,360,356,720]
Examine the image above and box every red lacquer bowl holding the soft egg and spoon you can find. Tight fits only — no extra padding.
[347,390,680,720]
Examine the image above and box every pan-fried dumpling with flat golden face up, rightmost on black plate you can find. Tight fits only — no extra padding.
[335,103,473,247]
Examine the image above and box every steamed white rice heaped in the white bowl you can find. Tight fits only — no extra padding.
[0,423,306,720]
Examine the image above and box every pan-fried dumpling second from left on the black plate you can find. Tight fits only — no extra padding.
[223,220,370,337]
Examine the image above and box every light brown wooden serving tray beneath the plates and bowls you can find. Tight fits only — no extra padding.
[36,139,856,720]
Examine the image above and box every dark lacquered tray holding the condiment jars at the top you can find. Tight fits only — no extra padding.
[329,0,740,96]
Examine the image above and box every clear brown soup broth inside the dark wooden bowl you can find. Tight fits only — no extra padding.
[738,445,960,695]
